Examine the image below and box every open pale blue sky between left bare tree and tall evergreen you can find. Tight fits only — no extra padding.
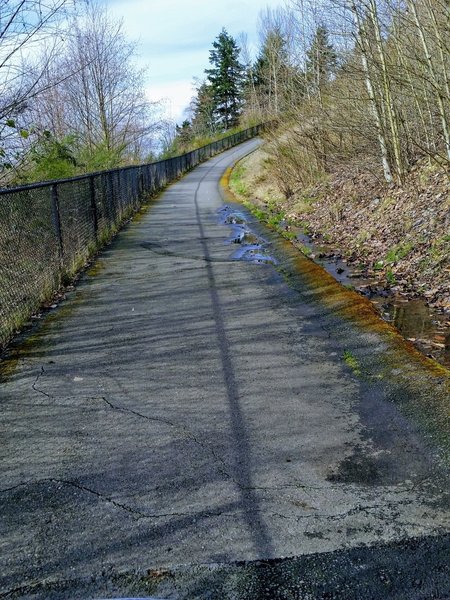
[107,0,279,123]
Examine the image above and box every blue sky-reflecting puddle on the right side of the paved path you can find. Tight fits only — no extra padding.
[219,206,277,265]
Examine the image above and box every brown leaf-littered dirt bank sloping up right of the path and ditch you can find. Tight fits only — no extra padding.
[231,149,450,312]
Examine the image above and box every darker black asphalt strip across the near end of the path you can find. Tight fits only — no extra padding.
[0,535,450,600]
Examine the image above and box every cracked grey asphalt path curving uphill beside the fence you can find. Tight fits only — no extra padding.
[0,141,450,599]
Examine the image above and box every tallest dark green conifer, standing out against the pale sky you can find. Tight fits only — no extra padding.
[205,29,244,129]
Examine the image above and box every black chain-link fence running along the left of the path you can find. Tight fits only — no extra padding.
[0,125,261,347]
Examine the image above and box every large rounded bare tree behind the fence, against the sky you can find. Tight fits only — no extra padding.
[27,2,156,168]
